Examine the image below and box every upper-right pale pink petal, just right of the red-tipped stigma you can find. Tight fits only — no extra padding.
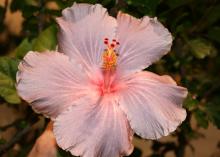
[117,12,172,76]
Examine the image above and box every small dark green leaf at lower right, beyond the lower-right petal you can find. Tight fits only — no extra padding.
[193,109,209,129]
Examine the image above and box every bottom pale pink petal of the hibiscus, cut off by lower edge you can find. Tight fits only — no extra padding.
[54,96,133,157]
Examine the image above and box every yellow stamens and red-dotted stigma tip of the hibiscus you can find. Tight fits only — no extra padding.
[102,38,119,71]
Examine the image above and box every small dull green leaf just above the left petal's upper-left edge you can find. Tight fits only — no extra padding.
[13,38,32,59]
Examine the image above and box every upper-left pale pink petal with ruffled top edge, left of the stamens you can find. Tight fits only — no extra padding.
[57,4,117,67]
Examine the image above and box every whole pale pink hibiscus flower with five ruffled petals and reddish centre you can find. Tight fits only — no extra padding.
[17,4,187,157]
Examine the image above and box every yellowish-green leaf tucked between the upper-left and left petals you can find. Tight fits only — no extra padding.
[32,25,57,51]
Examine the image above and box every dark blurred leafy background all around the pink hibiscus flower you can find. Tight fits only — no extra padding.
[0,0,220,157]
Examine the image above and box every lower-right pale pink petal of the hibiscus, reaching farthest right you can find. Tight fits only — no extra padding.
[119,72,187,139]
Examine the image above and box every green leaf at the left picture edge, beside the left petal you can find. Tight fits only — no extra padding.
[0,57,21,104]
